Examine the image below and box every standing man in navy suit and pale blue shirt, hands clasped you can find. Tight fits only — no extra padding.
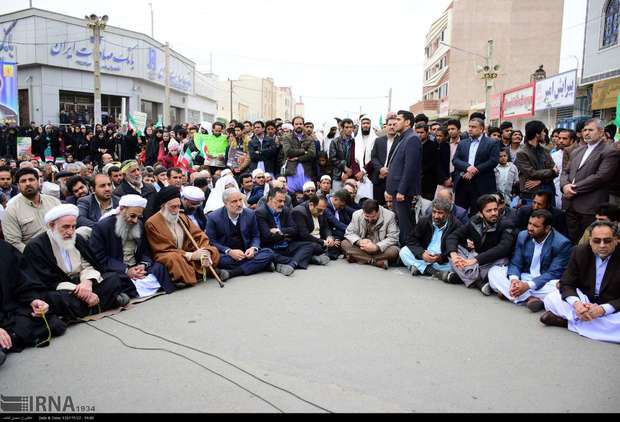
[452,118,499,215]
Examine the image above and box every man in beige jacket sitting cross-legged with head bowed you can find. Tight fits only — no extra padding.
[342,199,400,270]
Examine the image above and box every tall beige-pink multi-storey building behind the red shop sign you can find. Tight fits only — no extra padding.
[411,0,564,119]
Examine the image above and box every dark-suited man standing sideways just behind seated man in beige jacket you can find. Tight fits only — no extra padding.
[386,111,422,245]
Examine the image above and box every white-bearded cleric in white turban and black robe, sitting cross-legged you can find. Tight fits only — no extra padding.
[24,204,128,320]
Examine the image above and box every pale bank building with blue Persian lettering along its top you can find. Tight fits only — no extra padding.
[0,8,217,124]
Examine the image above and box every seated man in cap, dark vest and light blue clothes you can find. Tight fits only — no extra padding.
[400,198,461,277]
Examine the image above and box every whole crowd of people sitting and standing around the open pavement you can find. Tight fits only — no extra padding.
[0,111,620,370]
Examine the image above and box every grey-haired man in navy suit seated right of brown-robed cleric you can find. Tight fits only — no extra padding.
[207,188,273,278]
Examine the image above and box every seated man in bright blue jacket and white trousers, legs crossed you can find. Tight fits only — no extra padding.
[489,210,573,312]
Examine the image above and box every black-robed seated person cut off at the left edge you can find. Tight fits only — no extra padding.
[0,240,67,365]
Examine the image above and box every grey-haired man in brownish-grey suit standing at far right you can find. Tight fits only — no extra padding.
[560,119,619,244]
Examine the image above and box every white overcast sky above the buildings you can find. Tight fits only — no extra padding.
[0,0,587,124]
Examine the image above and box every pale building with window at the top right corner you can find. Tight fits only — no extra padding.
[581,0,620,122]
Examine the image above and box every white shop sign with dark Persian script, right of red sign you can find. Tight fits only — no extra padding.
[535,70,577,111]
